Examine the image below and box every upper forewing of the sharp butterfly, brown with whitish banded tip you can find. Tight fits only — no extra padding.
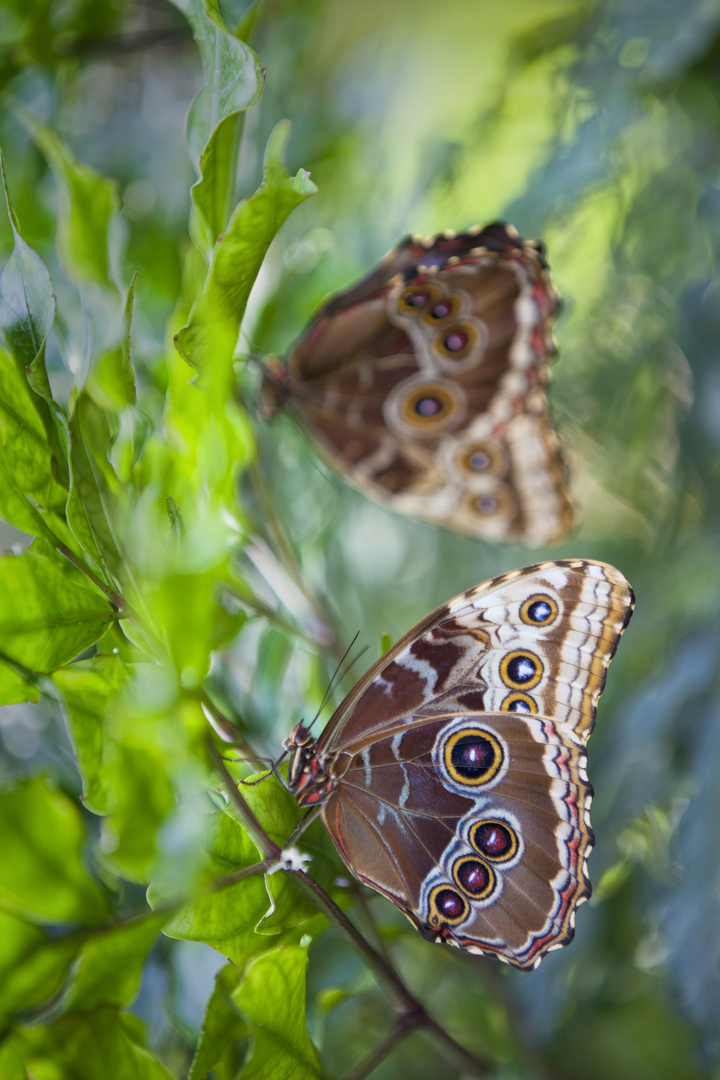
[322,559,635,750]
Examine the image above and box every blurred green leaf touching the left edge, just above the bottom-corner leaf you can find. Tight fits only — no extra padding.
[0,910,80,1019]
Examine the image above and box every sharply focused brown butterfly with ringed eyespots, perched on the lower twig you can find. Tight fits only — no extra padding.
[285,559,634,970]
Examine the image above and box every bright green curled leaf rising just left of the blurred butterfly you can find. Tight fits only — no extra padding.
[175,122,316,399]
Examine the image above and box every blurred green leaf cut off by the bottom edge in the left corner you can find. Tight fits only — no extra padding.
[12,1005,174,1080]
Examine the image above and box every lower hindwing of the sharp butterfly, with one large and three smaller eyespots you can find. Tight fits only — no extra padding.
[323,710,593,969]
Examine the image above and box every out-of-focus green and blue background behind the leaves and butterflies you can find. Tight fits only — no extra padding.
[0,0,720,1080]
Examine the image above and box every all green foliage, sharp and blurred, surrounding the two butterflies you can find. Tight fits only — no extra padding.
[0,0,720,1080]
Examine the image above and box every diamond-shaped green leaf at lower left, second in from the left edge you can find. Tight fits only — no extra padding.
[63,915,165,1010]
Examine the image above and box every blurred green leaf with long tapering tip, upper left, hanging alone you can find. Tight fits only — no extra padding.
[14,104,120,286]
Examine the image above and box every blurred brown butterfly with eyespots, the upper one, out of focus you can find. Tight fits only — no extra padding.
[261,222,574,546]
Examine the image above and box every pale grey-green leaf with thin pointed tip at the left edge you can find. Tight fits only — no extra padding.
[0,153,55,367]
